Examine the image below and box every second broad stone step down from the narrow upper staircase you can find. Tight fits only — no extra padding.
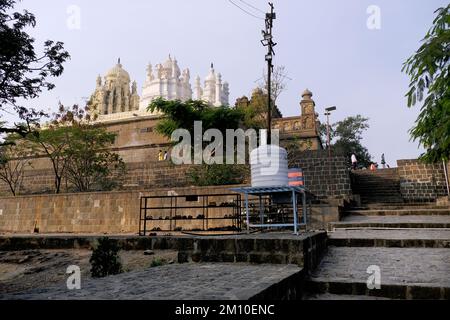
[330,215,450,229]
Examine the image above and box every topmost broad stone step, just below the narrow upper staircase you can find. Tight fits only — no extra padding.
[345,208,450,216]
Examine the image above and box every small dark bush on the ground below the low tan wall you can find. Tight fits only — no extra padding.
[89,237,123,278]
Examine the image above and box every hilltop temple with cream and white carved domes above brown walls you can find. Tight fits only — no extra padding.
[85,56,322,163]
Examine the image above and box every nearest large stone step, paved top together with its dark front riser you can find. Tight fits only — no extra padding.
[305,246,450,300]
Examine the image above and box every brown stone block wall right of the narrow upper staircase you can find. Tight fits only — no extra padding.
[397,159,447,202]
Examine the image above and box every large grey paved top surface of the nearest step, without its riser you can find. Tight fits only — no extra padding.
[312,247,450,287]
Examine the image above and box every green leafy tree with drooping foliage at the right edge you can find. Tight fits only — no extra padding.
[402,5,450,162]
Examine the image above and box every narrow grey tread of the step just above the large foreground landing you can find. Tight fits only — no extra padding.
[328,228,450,241]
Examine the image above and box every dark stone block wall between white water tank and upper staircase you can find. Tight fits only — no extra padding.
[292,150,352,199]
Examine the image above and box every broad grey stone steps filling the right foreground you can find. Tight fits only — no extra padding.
[304,200,450,300]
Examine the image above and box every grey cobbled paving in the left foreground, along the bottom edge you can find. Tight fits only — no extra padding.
[0,263,301,300]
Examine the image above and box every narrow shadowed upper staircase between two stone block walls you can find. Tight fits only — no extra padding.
[351,168,403,204]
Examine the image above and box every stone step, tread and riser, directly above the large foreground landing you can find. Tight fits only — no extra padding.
[328,228,450,248]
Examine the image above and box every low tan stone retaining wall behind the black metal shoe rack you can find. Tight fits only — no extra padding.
[0,187,243,234]
